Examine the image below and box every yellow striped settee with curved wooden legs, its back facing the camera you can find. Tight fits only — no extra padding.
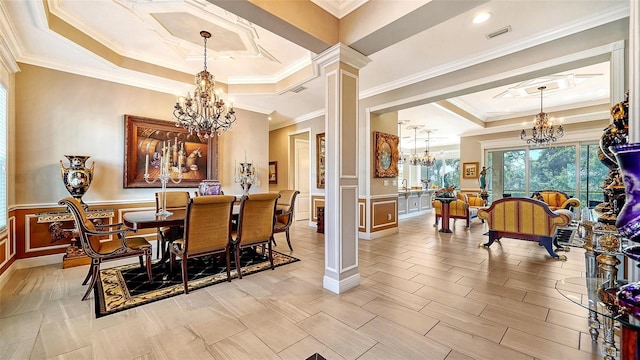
[478,198,573,260]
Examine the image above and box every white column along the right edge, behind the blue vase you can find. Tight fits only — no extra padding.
[629,0,640,282]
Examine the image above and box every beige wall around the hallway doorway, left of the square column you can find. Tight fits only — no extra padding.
[269,116,325,194]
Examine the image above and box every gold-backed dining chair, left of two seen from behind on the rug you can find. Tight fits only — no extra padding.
[169,195,236,294]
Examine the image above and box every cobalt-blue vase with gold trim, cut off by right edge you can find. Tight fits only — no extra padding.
[613,143,640,241]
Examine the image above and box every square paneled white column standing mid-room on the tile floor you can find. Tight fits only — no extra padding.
[314,44,370,294]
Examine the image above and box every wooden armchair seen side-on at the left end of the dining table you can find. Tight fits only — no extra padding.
[58,197,153,300]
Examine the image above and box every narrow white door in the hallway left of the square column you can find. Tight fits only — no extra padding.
[293,139,311,220]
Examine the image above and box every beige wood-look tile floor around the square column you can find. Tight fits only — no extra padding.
[0,215,612,360]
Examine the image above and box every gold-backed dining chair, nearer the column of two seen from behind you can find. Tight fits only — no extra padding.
[233,193,280,279]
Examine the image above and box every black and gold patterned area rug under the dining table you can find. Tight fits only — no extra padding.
[94,248,300,318]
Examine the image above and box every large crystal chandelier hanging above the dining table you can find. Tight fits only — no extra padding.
[173,30,236,139]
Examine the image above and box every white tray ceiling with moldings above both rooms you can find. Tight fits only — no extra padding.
[0,0,629,148]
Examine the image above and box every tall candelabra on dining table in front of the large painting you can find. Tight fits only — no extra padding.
[144,138,184,216]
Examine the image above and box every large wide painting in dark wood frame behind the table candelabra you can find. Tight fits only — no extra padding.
[123,115,218,188]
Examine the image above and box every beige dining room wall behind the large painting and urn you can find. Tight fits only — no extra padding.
[14,64,268,205]
